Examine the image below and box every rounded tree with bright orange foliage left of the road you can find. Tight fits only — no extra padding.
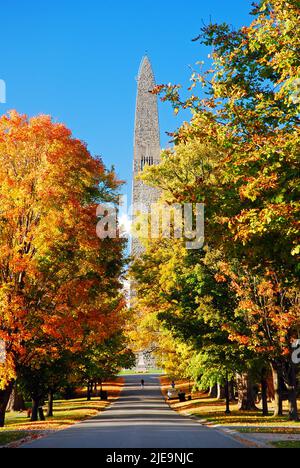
[0,112,124,426]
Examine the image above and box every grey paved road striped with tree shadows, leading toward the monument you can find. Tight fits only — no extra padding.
[23,375,243,449]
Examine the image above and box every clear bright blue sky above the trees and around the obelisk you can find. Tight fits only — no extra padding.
[0,0,251,199]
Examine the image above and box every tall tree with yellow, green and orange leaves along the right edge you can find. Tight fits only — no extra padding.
[132,0,300,420]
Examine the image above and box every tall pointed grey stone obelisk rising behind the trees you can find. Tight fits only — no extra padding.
[131,57,160,257]
